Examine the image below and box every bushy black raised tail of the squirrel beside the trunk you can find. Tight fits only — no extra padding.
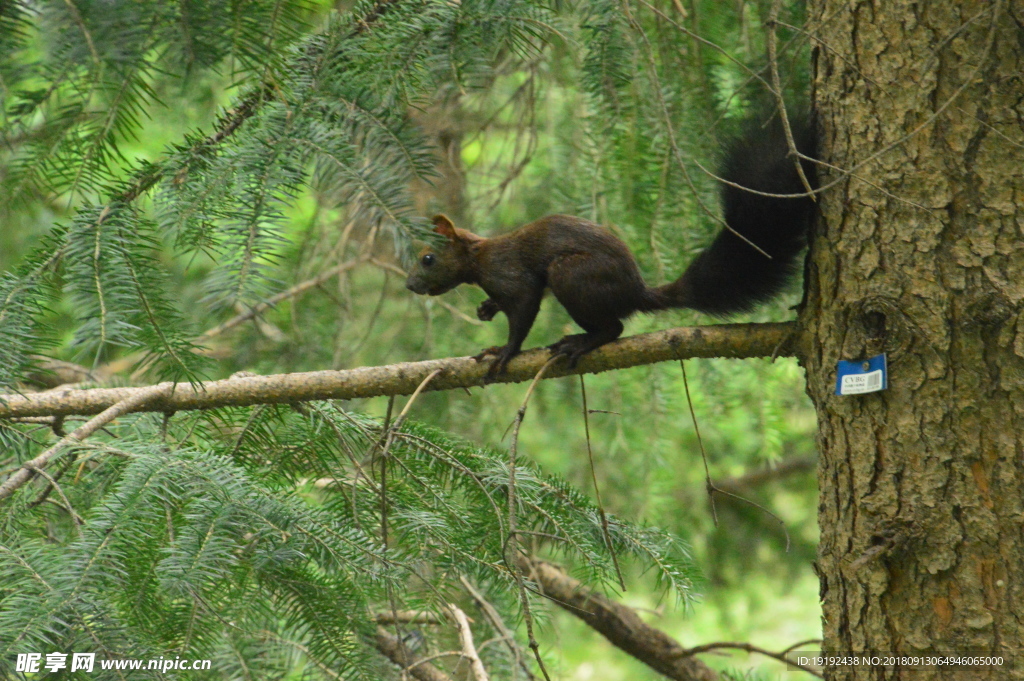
[645,116,817,314]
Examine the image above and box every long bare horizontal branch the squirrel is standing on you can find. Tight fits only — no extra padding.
[0,323,796,418]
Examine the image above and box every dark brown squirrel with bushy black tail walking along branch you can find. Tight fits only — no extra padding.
[406,116,817,375]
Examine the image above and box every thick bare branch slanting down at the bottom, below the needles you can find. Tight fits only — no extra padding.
[519,557,719,681]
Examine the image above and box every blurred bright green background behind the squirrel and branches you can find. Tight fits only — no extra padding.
[0,0,820,681]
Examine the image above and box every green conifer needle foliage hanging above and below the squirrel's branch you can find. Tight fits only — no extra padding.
[0,0,815,679]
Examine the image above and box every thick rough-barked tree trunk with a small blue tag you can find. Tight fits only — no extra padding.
[801,0,1024,681]
